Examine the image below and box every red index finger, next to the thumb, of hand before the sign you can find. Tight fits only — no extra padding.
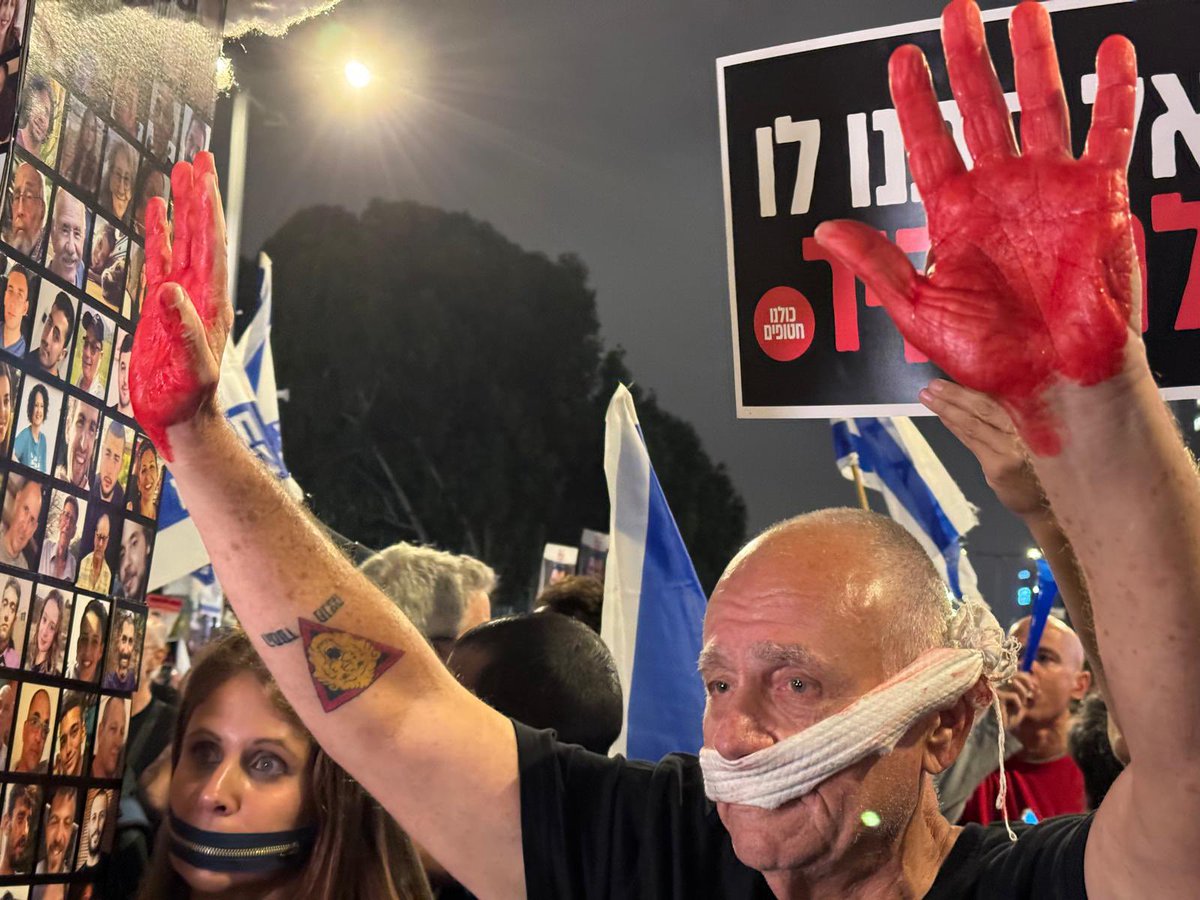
[888,44,966,197]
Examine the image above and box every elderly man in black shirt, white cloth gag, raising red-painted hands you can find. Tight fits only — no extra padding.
[131,0,1200,900]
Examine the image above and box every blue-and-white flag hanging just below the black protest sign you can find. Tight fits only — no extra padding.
[832,416,979,599]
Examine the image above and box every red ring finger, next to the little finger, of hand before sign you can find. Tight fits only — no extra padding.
[1009,0,1072,157]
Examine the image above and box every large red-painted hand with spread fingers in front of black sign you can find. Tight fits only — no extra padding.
[816,0,1139,454]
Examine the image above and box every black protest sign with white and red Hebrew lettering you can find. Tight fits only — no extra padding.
[719,0,1200,418]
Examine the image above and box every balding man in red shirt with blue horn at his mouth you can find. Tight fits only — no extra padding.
[959,616,1092,824]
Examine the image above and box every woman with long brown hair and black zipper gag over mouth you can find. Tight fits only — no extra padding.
[138,632,430,900]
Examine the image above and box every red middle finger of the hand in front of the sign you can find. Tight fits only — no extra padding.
[942,0,1016,163]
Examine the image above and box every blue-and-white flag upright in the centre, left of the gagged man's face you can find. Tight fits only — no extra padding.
[600,386,707,761]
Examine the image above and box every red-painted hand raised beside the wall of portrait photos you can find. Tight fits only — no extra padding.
[130,152,233,460]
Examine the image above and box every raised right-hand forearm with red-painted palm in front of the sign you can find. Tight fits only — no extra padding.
[817,0,1200,899]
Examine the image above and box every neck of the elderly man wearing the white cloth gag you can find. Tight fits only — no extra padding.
[766,778,962,900]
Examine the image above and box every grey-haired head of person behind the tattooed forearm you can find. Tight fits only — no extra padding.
[359,542,496,662]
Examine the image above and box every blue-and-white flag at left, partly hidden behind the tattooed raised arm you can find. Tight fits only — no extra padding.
[150,253,304,588]
